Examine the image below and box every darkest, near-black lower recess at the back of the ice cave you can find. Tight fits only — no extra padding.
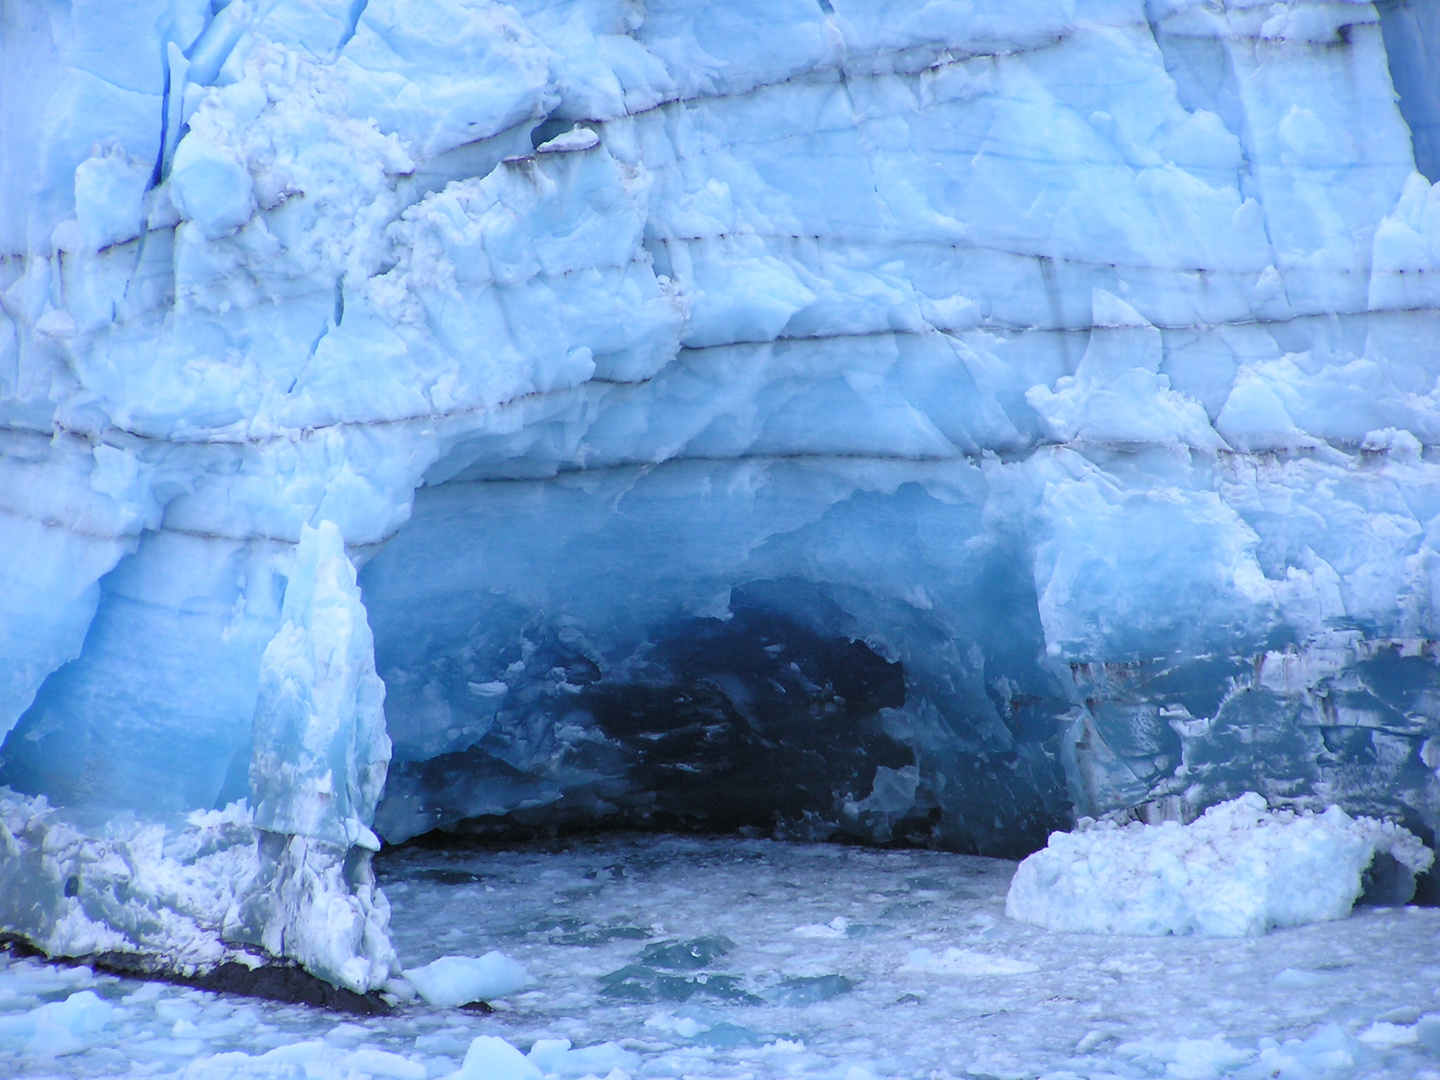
[380,601,961,845]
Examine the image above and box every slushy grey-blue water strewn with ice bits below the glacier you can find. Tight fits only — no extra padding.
[0,837,1440,1080]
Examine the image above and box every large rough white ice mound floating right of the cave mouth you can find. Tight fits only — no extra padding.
[1005,793,1434,937]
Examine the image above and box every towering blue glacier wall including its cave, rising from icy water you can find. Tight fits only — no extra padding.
[0,0,1440,991]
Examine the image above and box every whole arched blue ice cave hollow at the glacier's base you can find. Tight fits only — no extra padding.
[360,462,1071,857]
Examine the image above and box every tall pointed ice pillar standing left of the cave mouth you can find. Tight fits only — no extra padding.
[226,521,397,992]
